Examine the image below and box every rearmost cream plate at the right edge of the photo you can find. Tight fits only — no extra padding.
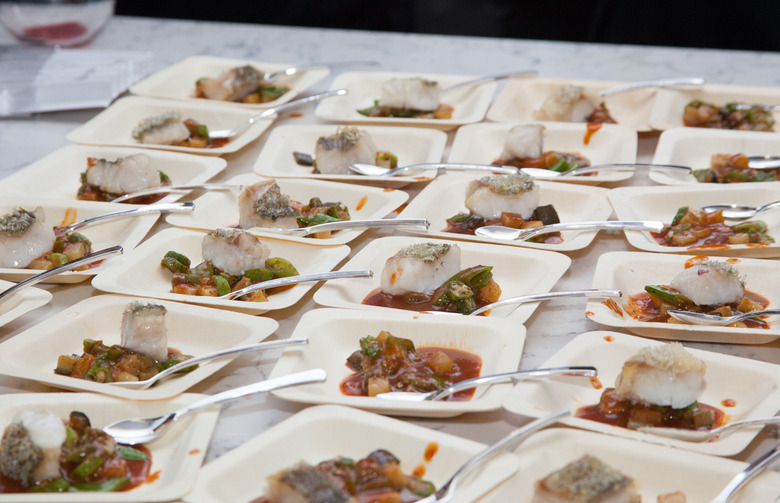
[649,84,780,131]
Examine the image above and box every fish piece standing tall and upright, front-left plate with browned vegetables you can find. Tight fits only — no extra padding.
[122,300,168,361]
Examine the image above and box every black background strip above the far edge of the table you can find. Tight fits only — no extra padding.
[116,0,780,52]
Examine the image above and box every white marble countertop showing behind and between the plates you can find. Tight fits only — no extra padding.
[0,17,780,496]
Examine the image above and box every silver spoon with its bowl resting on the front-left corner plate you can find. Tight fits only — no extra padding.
[103,369,327,445]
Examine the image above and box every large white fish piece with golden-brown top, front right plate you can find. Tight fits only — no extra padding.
[615,342,706,409]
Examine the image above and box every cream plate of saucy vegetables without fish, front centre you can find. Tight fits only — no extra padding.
[266,309,525,417]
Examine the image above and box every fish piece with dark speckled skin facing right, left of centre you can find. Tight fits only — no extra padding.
[238,180,301,229]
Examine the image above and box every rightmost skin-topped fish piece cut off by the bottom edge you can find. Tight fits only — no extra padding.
[532,455,641,503]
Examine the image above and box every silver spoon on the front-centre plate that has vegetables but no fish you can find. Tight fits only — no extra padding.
[374,366,598,402]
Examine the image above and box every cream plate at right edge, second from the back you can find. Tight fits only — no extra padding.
[650,127,780,185]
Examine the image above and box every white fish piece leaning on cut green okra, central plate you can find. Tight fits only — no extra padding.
[380,243,460,295]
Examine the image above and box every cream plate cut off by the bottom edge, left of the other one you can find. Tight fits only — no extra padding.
[184,405,517,503]
